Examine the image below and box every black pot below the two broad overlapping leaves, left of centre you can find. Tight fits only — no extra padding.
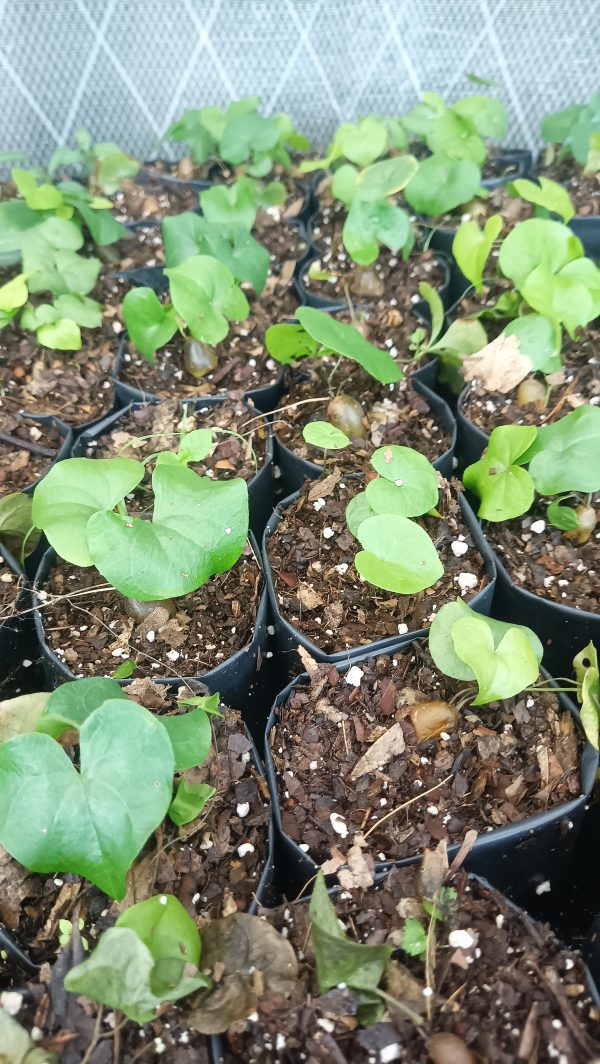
[33,533,269,741]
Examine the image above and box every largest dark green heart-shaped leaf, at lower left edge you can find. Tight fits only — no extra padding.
[0,699,174,898]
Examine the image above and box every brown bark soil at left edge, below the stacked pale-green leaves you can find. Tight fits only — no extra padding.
[0,326,114,425]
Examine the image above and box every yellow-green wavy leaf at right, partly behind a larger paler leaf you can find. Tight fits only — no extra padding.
[463,425,537,521]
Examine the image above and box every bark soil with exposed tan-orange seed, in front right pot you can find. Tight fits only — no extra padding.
[270,644,581,871]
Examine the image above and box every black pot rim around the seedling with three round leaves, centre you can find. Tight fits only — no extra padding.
[263,487,496,675]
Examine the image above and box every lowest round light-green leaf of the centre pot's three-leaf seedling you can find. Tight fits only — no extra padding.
[354,514,444,595]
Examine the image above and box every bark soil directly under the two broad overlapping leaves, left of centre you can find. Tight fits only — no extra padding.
[43,545,262,677]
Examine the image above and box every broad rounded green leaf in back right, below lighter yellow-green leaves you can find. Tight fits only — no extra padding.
[404,154,481,217]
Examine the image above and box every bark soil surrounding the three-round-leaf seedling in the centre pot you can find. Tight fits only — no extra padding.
[267,469,488,653]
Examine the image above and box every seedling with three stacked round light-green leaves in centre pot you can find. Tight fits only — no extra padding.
[346,446,444,595]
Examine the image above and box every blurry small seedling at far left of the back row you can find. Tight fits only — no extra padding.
[48,129,139,196]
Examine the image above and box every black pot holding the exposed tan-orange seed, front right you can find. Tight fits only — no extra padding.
[264,638,599,914]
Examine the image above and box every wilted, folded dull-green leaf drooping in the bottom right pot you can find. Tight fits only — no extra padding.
[310,871,394,994]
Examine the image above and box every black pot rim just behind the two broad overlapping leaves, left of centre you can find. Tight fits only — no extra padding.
[72,396,273,541]
